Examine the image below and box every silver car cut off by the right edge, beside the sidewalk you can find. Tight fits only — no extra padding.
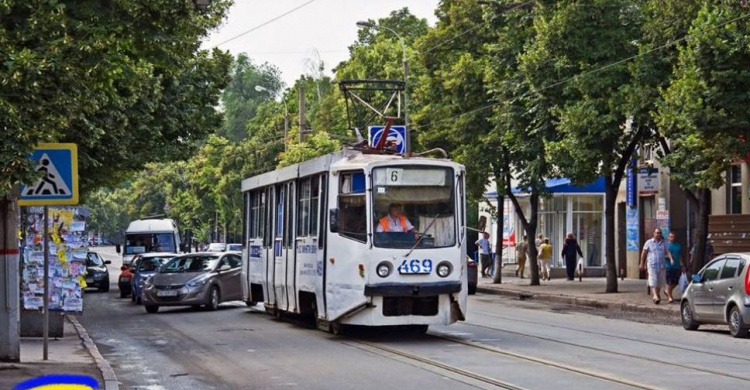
[680,253,750,337]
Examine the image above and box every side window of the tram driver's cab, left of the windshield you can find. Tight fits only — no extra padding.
[338,171,367,242]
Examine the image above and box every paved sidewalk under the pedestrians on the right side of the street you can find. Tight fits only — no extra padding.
[477,275,680,316]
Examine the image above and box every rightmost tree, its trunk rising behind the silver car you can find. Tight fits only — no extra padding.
[657,1,750,272]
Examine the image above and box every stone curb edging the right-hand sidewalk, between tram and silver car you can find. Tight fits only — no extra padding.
[477,286,679,316]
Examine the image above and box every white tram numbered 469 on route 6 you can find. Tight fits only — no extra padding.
[242,149,468,333]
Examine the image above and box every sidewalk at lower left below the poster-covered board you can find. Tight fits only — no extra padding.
[0,318,117,389]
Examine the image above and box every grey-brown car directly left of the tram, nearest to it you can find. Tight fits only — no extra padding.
[141,252,242,313]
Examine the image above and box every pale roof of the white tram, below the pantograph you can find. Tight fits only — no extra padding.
[242,149,458,192]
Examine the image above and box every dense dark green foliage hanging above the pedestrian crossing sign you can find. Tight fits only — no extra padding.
[0,0,230,193]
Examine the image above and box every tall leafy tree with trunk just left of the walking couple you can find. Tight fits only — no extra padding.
[524,0,646,292]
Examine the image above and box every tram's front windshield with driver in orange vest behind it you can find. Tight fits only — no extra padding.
[372,166,456,249]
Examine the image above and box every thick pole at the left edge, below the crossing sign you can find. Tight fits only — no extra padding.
[0,186,21,362]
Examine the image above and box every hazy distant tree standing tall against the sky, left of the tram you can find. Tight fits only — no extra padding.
[222,53,282,142]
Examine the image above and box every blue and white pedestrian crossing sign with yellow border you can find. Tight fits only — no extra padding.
[18,143,78,206]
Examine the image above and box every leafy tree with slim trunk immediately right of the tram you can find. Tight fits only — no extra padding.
[410,0,508,283]
